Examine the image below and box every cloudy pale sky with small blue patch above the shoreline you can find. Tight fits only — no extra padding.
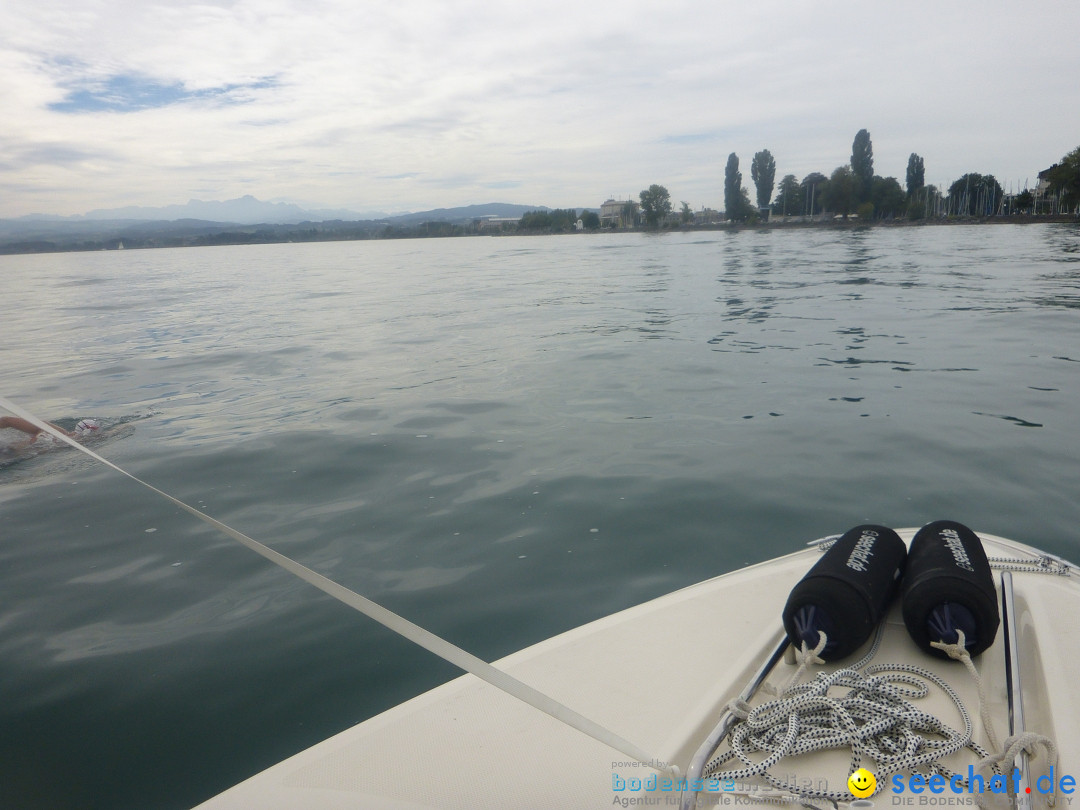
[0,0,1080,217]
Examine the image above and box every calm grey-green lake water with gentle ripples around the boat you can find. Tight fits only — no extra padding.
[0,225,1080,810]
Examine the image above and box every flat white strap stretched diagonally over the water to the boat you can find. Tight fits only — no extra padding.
[0,396,678,777]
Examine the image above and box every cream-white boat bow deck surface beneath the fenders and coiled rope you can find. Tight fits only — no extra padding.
[200,530,1080,810]
